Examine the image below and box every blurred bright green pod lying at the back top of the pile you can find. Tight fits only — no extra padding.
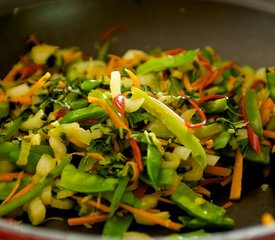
[137,50,196,75]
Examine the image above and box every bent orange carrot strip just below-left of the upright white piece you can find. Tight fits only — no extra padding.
[88,96,129,131]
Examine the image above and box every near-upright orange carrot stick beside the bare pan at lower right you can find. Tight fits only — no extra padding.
[229,149,243,200]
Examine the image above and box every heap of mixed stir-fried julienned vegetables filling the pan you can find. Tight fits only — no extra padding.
[0,34,275,238]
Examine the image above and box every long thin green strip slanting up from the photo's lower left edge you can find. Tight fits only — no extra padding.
[0,155,71,217]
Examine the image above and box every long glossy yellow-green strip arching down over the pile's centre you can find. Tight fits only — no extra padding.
[132,87,207,181]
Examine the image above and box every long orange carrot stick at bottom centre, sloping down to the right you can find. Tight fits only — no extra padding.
[119,203,184,231]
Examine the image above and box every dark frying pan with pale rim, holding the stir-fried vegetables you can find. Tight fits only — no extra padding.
[0,0,275,239]
